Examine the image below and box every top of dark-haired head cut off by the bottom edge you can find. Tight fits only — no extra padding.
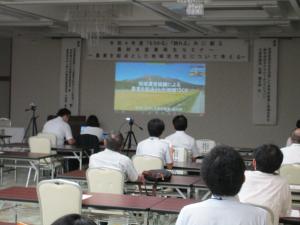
[52,213,96,225]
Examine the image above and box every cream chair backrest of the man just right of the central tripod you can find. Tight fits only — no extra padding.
[132,155,164,174]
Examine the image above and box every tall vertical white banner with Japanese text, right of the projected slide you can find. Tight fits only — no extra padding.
[253,39,278,125]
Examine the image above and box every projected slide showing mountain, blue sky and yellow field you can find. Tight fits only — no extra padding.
[114,62,206,114]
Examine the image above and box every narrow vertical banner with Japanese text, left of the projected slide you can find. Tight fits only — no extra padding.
[60,38,81,115]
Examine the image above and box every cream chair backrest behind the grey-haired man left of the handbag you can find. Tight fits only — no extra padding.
[86,168,125,194]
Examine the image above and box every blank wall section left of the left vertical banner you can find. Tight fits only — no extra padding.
[11,37,60,128]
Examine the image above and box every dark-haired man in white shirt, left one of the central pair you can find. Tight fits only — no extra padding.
[136,119,173,169]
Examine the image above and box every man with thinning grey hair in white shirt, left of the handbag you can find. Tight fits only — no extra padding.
[89,132,142,181]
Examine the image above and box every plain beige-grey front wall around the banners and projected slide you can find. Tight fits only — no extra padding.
[12,38,300,147]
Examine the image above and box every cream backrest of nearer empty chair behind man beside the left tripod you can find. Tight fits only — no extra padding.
[28,136,51,154]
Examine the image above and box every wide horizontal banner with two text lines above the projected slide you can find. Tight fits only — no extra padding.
[87,39,249,62]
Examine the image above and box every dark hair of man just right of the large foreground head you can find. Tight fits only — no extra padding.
[253,144,283,173]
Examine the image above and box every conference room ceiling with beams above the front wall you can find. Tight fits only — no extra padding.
[0,0,300,38]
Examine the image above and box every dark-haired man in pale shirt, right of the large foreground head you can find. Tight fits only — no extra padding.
[239,144,292,225]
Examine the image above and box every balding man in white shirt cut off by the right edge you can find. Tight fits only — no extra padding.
[281,128,300,165]
